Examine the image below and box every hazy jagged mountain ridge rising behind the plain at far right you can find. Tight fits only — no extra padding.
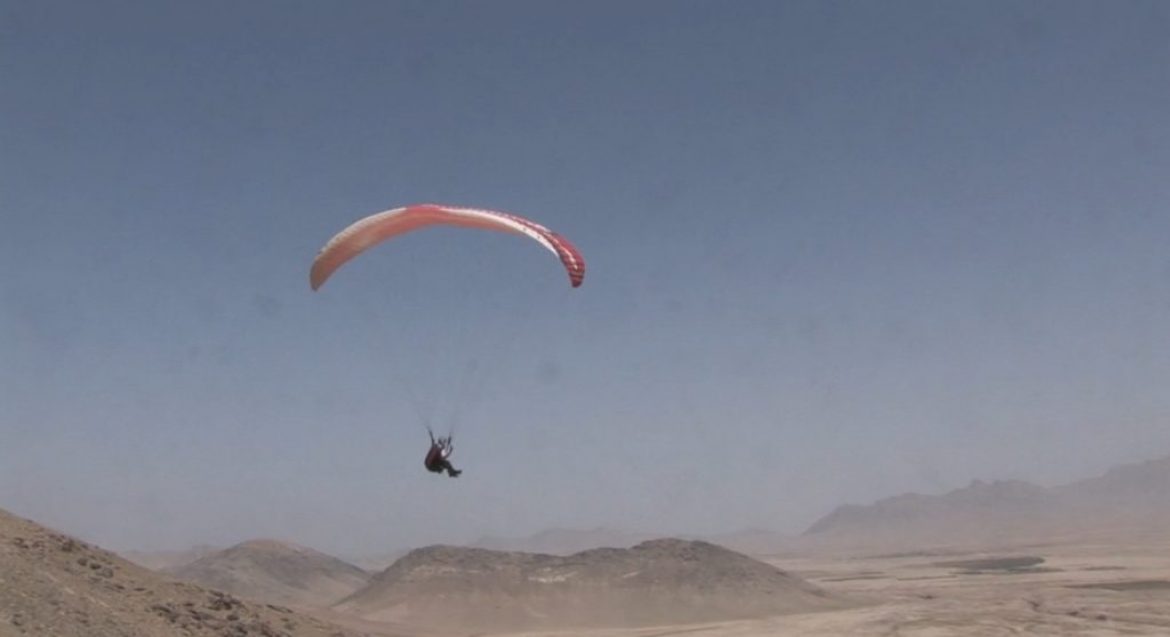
[803,458,1170,544]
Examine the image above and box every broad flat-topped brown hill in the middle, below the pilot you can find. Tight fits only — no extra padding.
[335,539,846,630]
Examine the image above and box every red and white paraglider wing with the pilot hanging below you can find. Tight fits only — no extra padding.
[309,204,585,478]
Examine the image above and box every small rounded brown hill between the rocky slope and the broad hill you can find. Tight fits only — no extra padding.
[167,540,370,607]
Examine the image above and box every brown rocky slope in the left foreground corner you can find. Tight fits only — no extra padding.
[0,511,352,637]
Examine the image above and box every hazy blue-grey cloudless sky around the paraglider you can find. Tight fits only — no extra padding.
[0,0,1170,554]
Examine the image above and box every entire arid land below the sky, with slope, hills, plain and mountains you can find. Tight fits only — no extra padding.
[0,451,1170,637]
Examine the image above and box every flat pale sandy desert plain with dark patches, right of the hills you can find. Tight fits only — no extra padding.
[486,541,1170,637]
